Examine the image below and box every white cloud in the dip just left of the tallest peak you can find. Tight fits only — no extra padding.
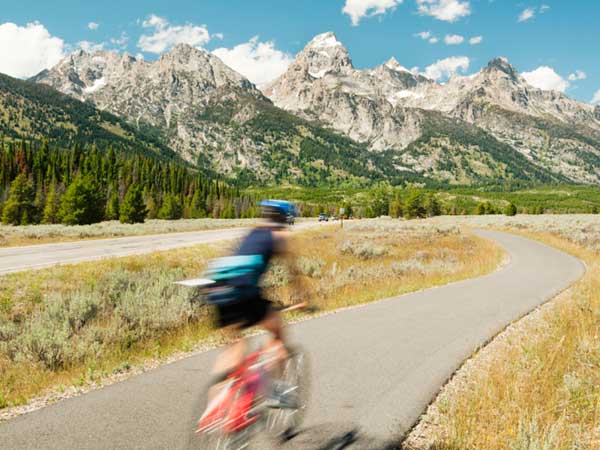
[213,36,293,86]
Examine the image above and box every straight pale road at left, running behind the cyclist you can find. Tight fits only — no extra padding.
[0,222,319,275]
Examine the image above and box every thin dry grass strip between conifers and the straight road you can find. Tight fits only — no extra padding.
[0,219,257,248]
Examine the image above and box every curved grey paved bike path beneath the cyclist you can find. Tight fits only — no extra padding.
[0,231,584,450]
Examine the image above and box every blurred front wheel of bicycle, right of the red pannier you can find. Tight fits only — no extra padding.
[267,347,310,438]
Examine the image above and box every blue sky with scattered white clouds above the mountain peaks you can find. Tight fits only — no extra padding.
[0,0,600,102]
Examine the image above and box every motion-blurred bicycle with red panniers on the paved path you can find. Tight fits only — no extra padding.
[177,279,310,450]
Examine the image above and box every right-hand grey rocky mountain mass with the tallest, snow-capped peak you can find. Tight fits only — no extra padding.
[265,33,600,184]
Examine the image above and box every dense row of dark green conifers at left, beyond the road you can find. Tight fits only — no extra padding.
[0,141,259,225]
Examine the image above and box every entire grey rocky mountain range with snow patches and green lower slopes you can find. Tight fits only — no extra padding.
[15,33,600,184]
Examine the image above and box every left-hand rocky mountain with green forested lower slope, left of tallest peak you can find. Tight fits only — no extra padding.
[33,45,395,184]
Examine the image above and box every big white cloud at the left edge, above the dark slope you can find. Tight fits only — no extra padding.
[0,22,66,78]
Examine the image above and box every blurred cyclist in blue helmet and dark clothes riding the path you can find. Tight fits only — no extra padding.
[209,200,297,395]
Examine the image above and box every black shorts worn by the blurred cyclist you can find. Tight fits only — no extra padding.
[217,287,272,328]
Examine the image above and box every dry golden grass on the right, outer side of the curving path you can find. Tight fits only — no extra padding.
[405,216,600,450]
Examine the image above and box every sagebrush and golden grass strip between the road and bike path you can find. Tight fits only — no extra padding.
[0,220,503,416]
